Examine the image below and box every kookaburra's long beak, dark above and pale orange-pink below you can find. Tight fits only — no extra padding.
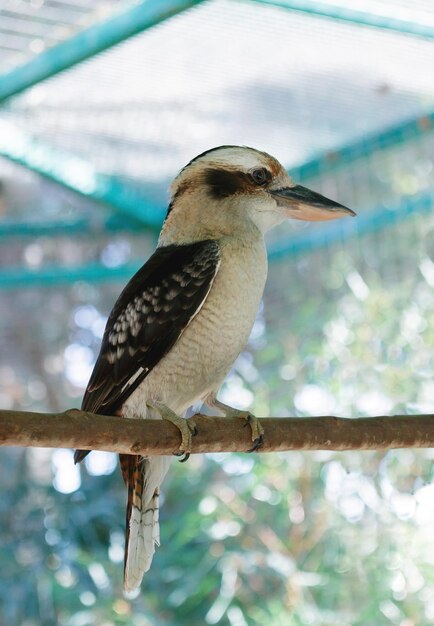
[269,185,356,222]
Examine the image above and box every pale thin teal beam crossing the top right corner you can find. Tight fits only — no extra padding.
[251,0,434,39]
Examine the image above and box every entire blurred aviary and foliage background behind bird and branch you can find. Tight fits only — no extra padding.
[0,0,434,626]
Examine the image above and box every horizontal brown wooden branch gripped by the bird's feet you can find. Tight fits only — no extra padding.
[0,409,434,455]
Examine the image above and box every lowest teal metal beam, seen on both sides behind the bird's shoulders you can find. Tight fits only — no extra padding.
[0,192,434,290]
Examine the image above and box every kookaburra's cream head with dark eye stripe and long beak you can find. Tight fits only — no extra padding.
[162,146,355,243]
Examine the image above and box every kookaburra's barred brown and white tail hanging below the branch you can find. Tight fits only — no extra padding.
[121,455,171,591]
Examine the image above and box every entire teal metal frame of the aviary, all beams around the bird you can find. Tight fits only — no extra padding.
[0,0,434,289]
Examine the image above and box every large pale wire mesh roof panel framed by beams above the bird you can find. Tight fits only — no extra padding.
[2,0,434,193]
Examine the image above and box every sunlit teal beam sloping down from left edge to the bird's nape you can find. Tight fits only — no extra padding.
[0,120,164,231]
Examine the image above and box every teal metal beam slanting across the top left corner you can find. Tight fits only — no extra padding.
[0,0,204,102]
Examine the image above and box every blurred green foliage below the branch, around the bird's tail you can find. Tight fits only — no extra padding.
[0,442,434,626]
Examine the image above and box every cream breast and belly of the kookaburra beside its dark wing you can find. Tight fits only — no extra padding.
[123,233,267,417]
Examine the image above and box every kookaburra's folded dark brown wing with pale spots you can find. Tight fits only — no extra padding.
[75,240,220,461]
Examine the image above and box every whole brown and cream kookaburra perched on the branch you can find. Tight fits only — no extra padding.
[74,145,355,591]
